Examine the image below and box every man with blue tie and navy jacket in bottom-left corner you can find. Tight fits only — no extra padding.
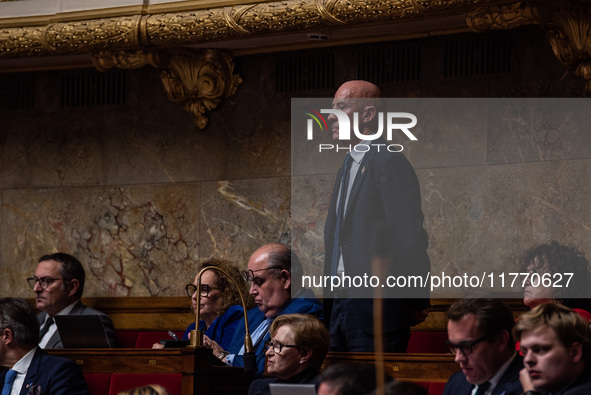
[0,298,89,395]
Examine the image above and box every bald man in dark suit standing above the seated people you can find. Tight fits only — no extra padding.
[324,81,430,352]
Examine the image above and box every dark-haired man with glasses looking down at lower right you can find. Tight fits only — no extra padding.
[443,299,523,395]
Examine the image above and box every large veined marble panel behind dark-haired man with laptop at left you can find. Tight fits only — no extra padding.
[0,183,200,297]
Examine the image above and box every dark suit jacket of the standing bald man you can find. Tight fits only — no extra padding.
[324,139,430,331]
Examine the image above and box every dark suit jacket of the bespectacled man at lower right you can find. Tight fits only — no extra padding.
[443,355,523,395]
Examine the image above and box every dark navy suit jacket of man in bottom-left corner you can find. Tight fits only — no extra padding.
[0,349,89,395]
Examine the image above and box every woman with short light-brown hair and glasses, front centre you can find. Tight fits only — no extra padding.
[248,314,330,395]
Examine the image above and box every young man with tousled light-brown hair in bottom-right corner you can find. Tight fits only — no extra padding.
[513,303,591,395]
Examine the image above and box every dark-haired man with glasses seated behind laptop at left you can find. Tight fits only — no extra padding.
[27,252,117,348]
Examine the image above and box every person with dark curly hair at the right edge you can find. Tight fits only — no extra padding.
[520,241,591,321]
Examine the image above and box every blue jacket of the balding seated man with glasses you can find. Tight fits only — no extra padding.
[228,291,322,377]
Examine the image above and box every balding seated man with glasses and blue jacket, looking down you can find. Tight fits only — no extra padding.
[204,244,322,376]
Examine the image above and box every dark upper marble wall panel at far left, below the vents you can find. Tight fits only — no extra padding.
[0,109,103,188]
